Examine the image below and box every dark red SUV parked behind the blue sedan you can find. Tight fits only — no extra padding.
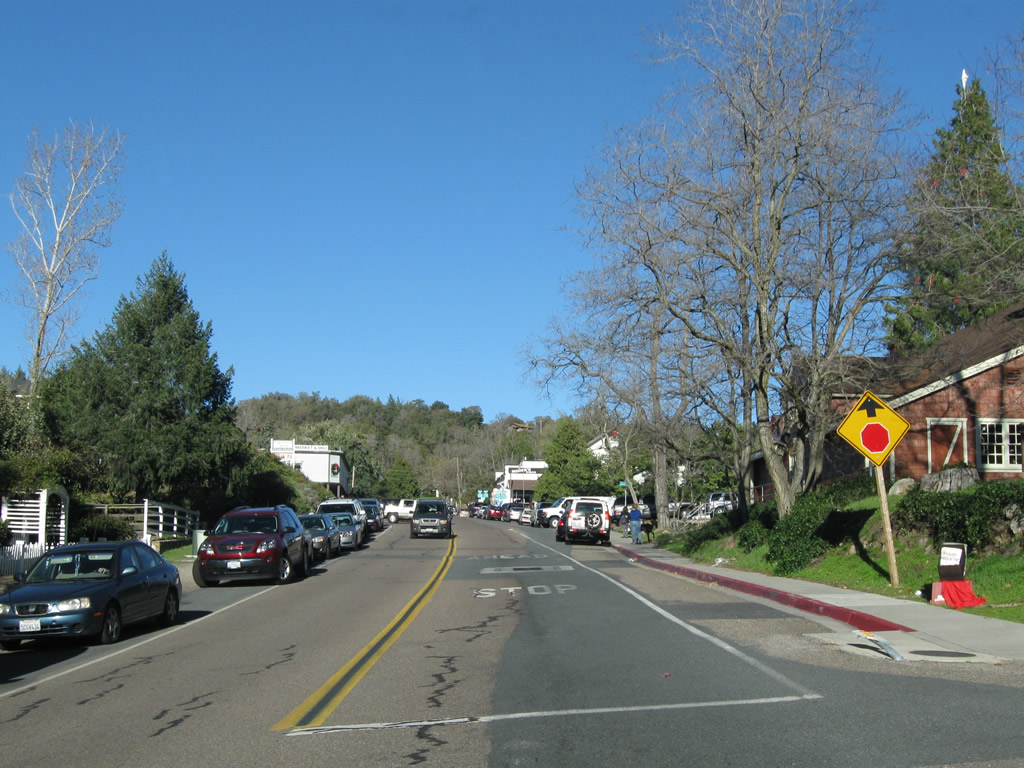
[193,505,311,587]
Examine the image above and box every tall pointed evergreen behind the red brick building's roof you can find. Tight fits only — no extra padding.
[887,80,1024,354]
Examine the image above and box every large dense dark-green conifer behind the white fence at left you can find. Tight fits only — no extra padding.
[43,254,249,506]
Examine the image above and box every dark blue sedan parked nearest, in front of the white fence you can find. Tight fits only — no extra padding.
[0,541,181,650]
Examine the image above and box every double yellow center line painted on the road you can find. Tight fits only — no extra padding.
[273,539,456,731]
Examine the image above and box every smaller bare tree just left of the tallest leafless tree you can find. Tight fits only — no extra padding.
[530,133,688,525]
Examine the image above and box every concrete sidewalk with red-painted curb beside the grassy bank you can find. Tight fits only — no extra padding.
[615,541,1024,664]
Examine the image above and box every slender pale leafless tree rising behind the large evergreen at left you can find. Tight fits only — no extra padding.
[7,123,124,394]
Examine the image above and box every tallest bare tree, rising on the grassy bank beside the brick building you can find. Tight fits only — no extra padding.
[646,0,905,515]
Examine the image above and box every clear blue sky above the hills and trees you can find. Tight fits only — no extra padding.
[0,0,1024,421]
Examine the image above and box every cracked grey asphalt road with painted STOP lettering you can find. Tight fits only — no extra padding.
[0,519,1024,768]
